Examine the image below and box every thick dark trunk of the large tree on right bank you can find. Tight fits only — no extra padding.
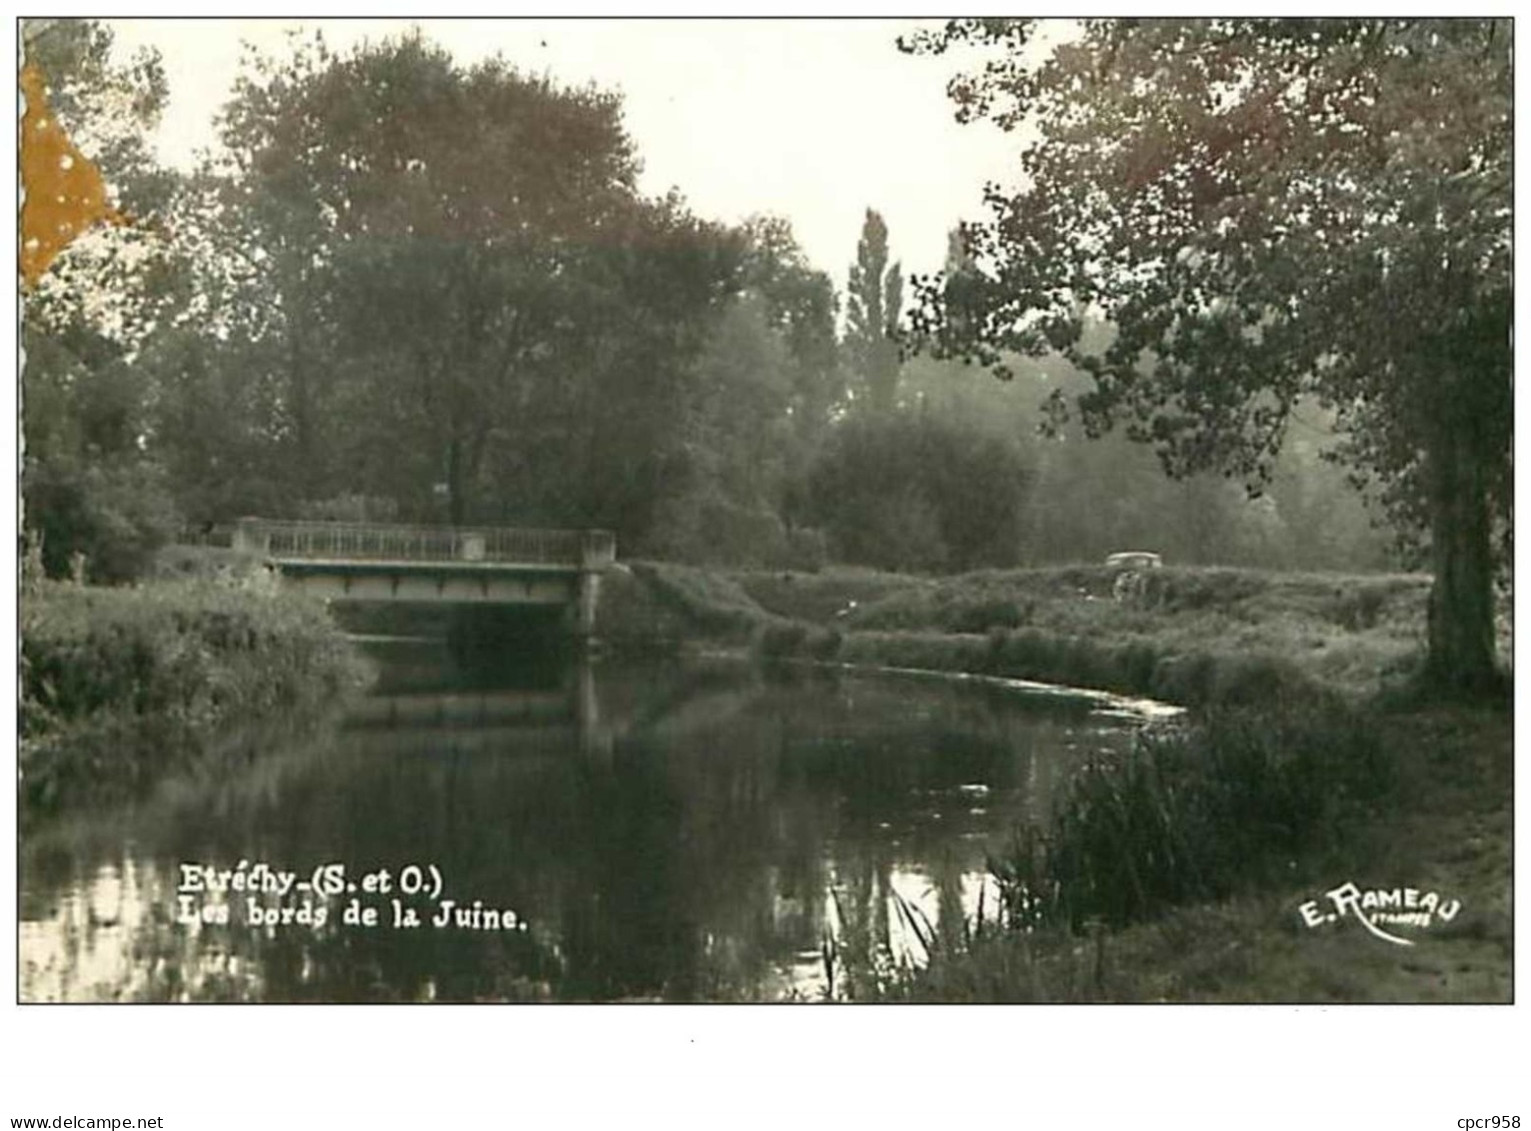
[1425,419,1497,695]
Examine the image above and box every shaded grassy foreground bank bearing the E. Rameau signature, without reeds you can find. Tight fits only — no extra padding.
[867,709,1514,1004]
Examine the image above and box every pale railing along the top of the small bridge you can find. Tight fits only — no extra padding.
[234,519,615,569]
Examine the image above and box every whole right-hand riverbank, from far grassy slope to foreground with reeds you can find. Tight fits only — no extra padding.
[606,565,1513,1002]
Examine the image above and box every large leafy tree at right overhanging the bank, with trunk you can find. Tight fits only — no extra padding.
[905,20,1513,690]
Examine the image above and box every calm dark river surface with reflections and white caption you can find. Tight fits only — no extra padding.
[20,644,1157,1002]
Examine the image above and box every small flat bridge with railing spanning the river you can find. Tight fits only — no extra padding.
[233,519,617,637]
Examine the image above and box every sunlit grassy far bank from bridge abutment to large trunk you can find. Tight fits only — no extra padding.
[313,562,1445,707]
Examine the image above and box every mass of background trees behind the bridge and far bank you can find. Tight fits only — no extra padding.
[23,20,1433,593]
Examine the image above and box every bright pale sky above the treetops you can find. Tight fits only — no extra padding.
[107,18,1017,286]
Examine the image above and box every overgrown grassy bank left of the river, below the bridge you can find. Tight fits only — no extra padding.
[20,580,363,813]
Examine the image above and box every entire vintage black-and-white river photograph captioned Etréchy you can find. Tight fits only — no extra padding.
[3,12,1531,1129]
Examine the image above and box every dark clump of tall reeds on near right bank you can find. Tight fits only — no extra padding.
[991,704,1393,932]
